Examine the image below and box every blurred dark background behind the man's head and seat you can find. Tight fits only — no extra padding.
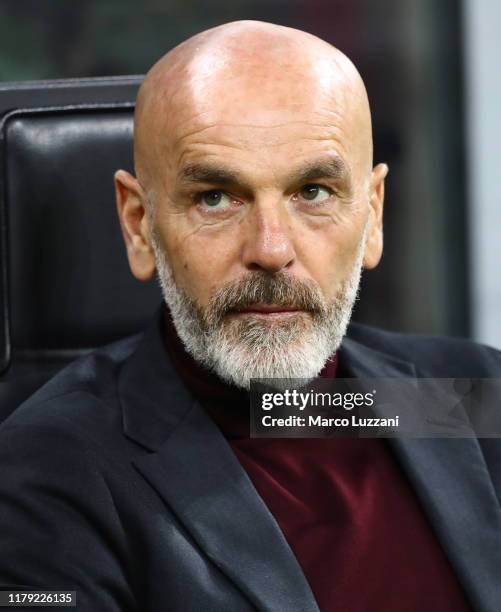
[0,0,480,335]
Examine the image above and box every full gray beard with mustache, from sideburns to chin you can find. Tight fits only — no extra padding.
[147,231,367,389]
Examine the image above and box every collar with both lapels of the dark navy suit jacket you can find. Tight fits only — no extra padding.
[118,311,501,612]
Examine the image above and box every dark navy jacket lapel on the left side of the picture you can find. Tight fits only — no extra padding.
[119,310,318,612]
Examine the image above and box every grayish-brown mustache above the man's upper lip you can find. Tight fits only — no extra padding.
[204,272,328,325]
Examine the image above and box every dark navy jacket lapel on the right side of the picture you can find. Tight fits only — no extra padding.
[340,339,501,612]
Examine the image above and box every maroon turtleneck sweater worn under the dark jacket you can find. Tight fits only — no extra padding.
[165,311,471,612]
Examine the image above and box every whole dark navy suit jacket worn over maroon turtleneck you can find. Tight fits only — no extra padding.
[0,314,501,612]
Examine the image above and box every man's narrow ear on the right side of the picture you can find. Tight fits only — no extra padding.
[363,164,388,270]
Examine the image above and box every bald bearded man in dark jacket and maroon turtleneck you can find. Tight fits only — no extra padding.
[0,22,501,612]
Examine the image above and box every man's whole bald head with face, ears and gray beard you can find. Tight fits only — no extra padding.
[115,21,387,378]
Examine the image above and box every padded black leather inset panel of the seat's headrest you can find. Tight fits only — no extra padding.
[2,104,161,366]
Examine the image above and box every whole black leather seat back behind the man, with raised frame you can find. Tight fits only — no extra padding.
[0,77,161,420]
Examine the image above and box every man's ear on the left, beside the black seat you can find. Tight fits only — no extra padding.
[115,170,155,281]
